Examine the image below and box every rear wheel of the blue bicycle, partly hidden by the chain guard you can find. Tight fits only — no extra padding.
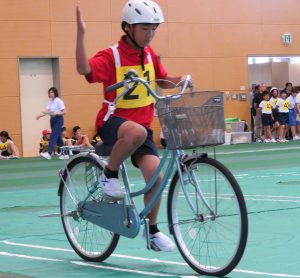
[60,156,120,262]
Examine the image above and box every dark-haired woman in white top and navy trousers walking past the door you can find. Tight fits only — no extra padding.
[36,87,68,159]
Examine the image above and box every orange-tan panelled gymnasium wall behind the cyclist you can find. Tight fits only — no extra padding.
[0,0,300,156]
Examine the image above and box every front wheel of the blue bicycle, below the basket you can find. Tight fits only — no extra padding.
[168,157,248,276]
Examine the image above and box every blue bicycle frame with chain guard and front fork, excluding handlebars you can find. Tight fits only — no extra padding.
[57,143,215,238]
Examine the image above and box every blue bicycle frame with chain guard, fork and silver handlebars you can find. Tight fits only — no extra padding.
[60,72,214,237]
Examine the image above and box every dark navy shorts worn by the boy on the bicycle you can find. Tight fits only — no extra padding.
[98,117,158,168]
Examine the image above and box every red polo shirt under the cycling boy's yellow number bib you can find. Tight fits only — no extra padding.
[86,36,167,127]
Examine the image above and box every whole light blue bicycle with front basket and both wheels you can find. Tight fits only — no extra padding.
[58,71,248,276]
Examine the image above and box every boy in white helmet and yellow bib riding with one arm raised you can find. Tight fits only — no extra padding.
[76,0,188,251]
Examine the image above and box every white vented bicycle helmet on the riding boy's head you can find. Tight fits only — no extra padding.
[122,0,164,24]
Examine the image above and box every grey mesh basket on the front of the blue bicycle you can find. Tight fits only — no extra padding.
[155,91,225,149]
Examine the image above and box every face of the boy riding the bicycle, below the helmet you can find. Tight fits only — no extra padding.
[128,24,158,47]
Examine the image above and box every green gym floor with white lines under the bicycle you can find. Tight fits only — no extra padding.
[0,142,300,278]
